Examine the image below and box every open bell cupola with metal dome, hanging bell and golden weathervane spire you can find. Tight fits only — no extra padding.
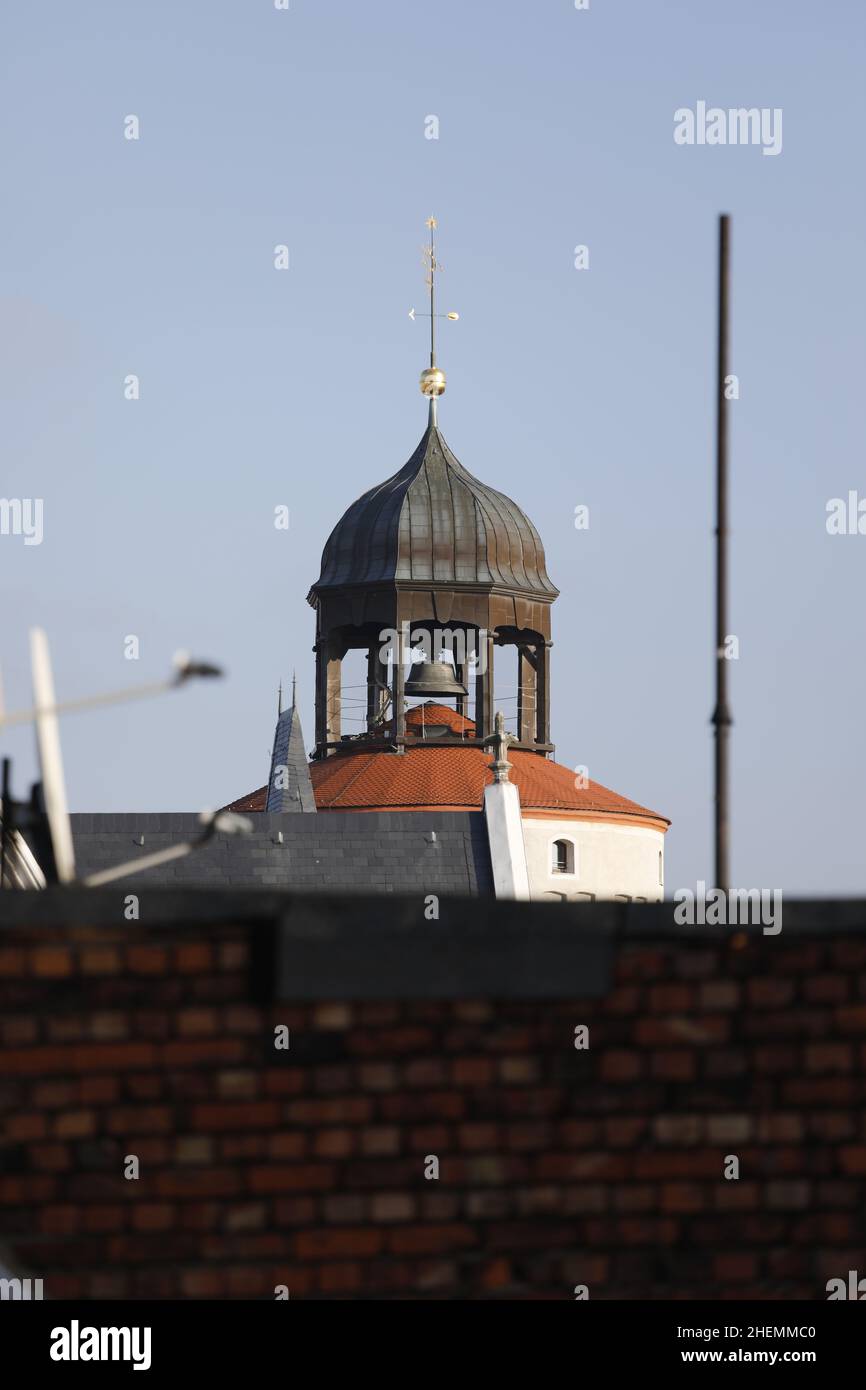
[307,218,559,759]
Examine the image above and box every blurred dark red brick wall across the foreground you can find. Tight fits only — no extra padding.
[0,894,866,1298]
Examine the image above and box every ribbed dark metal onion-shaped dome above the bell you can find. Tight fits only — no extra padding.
[311,424,559,599]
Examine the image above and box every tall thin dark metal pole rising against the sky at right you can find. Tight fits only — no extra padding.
[712,213,733,892]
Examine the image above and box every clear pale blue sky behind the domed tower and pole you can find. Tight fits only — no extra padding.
[0,0,866,897]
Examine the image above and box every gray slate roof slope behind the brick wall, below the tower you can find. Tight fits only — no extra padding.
[71,810,493,895]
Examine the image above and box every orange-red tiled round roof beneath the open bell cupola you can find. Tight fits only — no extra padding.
[229,702,669,830]
